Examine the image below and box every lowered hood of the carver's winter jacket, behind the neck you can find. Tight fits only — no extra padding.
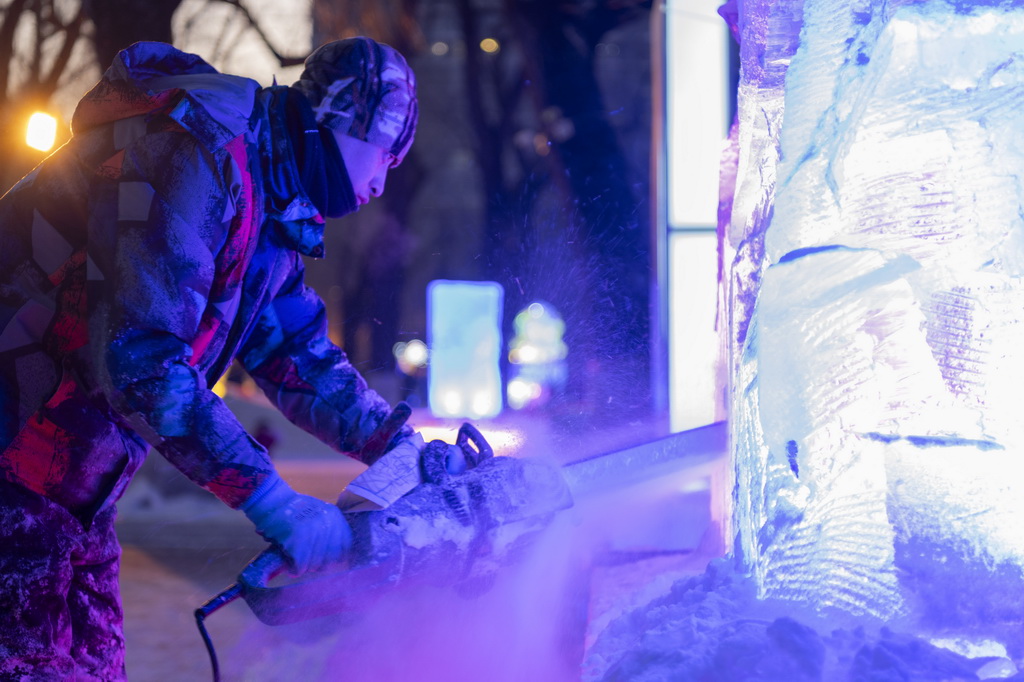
[72,42,259,148]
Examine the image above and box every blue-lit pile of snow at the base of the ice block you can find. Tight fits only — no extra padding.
[583,561,1024,682]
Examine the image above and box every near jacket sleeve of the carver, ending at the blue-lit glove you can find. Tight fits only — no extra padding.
[90,133,273,507]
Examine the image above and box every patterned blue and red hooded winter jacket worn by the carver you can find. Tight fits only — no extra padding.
[0,43,399,522]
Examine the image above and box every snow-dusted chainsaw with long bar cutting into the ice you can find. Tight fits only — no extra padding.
[196,410,726,682]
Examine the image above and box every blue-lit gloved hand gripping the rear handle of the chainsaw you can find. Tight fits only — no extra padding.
[242,474,352,574]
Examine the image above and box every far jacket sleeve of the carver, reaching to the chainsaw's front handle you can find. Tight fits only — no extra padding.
[239,251,403,458]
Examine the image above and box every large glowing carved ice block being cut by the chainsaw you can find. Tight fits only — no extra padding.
[720,0,1024,623]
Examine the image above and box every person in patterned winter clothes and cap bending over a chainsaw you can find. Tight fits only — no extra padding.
[0,38,422,681]
